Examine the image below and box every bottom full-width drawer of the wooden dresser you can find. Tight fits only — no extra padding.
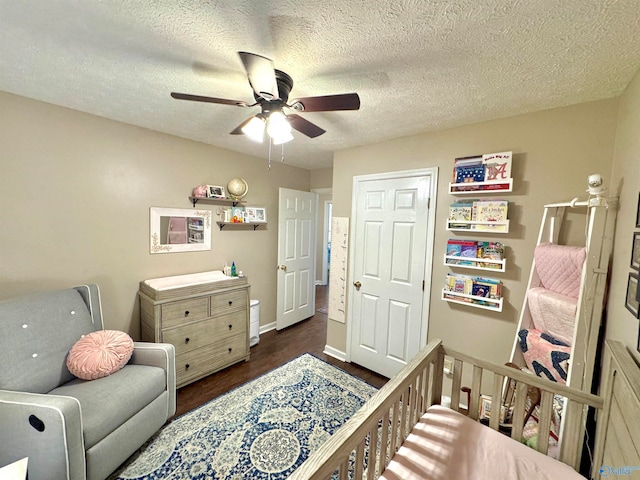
[176,334,247,387]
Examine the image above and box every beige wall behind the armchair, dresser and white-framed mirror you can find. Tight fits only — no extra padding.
[0,92,309,338]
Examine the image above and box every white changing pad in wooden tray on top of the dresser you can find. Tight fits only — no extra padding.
[140,270,247,300]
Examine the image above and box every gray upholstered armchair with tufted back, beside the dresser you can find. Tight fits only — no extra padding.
[0,285,176,480]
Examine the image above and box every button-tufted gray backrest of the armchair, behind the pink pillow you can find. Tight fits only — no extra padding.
[0,288,101,393]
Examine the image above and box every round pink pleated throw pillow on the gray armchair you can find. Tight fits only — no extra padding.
[67,330,133,380]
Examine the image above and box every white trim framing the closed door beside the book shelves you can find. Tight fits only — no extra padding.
[346,167,438,362]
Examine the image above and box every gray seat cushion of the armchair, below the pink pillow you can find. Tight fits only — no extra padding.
[49,365,166,450]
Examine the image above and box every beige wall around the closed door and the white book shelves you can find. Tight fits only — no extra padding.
[327,99,616,363]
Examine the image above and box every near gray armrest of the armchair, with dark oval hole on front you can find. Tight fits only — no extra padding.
[0,390,86,479]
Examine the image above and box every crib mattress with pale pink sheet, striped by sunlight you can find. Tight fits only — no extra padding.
[380,405,584,480]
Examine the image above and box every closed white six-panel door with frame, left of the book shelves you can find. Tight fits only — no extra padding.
[348,169,437,377]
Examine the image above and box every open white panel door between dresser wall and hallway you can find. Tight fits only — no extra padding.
[276,188,318,330]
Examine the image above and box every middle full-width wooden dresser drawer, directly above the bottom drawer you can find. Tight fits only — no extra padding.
[162,311,247,355]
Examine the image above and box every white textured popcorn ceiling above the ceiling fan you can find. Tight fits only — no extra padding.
[0,0,640,169]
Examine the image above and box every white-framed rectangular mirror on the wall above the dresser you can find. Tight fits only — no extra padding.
[149,207,211,253]
